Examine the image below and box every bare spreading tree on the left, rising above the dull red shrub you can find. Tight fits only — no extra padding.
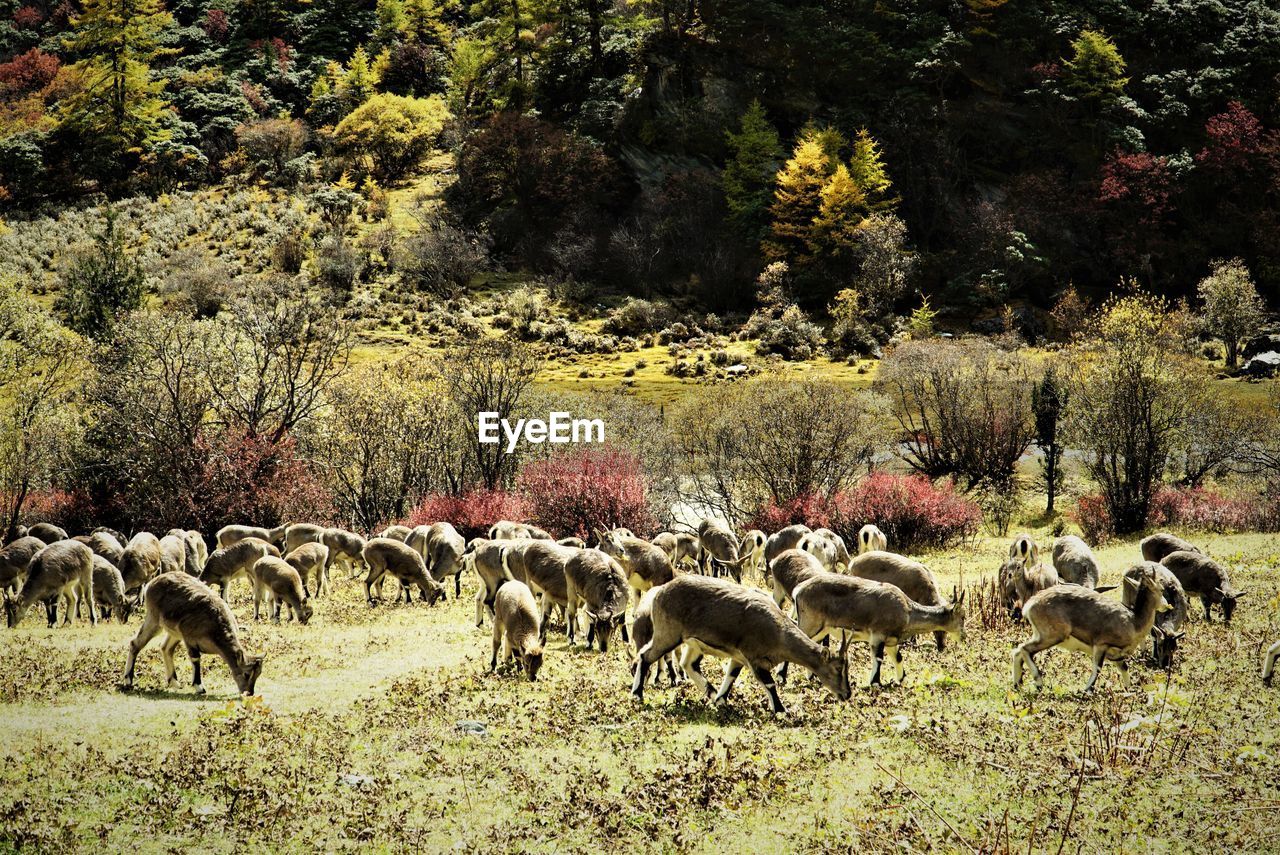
[209,283,351,443]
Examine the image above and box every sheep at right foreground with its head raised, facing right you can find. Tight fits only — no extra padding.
[1012,566,1170,692]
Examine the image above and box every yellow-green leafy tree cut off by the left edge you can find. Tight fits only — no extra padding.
[0,284,91,540]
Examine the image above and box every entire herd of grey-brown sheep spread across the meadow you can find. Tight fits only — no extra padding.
[0,520,1280,712]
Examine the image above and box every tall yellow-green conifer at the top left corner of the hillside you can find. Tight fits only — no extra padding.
[61,0,173,159]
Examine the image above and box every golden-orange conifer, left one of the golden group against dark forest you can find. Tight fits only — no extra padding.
[760,131,833,264]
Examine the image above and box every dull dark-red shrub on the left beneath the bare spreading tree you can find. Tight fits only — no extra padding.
[191,436,333,531]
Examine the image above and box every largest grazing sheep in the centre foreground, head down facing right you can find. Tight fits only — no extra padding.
[631,576,850,713]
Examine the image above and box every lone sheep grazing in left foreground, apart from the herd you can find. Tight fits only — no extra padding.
[120,570,262,695]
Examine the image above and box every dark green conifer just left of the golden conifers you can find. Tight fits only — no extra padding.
[721,101,782,244]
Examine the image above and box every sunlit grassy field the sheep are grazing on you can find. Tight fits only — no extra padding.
[0,535,1280,852]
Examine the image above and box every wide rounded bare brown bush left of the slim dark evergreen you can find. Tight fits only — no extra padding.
[878,339,1036,490]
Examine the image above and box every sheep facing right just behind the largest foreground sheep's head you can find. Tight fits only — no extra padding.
[795,573,965,686]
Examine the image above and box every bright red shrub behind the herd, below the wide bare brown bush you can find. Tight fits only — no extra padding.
[836,472,982,550]
